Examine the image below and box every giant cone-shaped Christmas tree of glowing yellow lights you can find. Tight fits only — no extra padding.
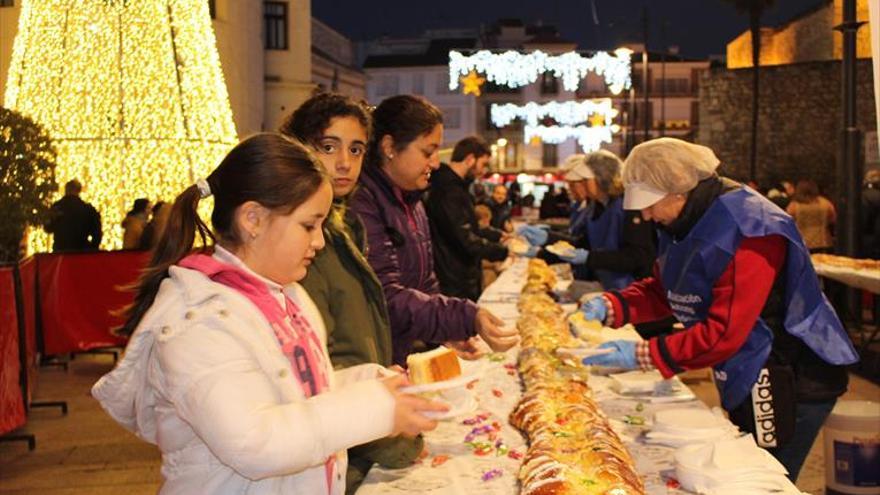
[5,0,236,251]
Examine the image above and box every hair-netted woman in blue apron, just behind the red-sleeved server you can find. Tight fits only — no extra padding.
[520,150,654,290]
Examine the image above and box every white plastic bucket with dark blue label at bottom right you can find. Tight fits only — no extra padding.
[824,400,880,495]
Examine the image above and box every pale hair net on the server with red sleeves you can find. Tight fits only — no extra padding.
[623,137,721,194]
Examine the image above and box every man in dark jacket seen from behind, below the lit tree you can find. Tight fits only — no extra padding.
[46,179,103,253]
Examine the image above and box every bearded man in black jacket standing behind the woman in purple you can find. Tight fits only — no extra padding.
[425,136,508,301]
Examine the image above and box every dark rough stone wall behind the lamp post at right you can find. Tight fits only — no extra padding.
[697,60,877,195]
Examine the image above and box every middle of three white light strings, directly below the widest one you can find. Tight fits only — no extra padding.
[489,98,618,127]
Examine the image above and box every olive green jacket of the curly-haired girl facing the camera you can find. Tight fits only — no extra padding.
[300,202,424,493]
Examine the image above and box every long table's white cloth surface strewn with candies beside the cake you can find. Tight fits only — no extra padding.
[357,259,706,495]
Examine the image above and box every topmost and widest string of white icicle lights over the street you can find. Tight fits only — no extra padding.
[449,48,632,94]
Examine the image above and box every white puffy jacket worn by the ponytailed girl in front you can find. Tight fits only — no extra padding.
[92,267,394,495]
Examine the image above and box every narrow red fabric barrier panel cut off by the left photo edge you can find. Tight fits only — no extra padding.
[0,267,26,434]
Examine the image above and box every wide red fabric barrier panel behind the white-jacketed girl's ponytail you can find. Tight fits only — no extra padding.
[37,251,149,356]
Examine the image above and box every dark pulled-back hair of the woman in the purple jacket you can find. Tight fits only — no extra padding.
[366,95,443,167]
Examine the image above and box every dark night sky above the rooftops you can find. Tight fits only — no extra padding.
[312,0,823,57]
